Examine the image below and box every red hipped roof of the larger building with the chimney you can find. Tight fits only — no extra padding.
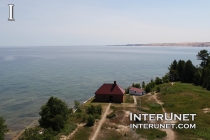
[95,84,125,94]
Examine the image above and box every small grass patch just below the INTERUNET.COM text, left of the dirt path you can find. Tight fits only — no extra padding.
[136,129,167,140]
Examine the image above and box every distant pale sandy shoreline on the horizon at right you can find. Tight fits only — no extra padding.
[107,42,210,47]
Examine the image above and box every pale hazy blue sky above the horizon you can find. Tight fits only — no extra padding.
[0,0,210,46]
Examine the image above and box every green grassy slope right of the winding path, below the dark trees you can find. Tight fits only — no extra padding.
[158,82,210,139]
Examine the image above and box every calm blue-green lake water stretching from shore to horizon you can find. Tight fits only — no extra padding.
[0,46,210,138]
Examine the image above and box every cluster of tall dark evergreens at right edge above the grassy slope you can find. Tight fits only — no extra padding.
[168,50,210,90]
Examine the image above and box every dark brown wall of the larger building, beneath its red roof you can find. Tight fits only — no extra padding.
[95,94,123,103]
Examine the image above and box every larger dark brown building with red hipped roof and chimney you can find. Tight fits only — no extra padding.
[95,81,125,103]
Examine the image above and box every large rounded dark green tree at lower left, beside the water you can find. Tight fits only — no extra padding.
[39,97,69,131]
